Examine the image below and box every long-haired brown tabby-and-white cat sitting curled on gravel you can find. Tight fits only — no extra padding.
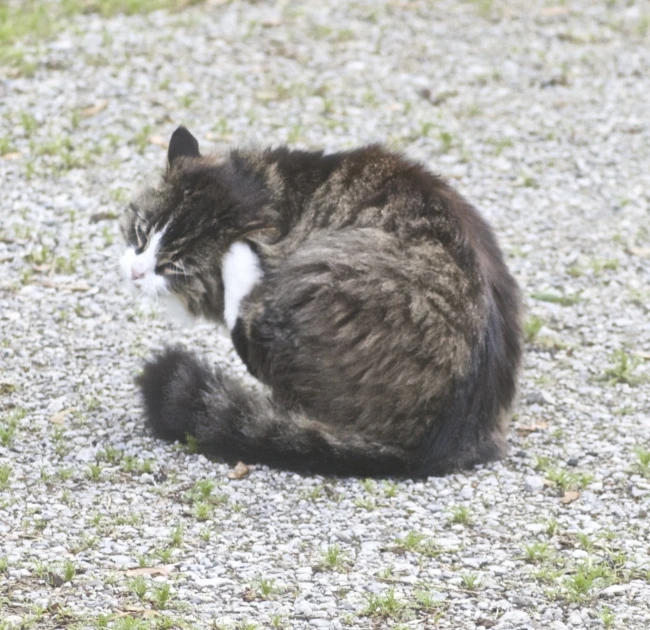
[121,127,522,478]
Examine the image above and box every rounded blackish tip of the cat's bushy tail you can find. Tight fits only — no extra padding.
[136,348,210,441]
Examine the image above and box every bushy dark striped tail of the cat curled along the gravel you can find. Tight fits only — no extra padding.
[137,348,413,476]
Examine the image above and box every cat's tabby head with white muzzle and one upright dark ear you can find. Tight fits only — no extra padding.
[120,127,228,318]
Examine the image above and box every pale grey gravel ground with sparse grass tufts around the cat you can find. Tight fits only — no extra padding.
[0,0,650,630]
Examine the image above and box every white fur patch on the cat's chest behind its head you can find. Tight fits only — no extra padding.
[221,241,262,330]
